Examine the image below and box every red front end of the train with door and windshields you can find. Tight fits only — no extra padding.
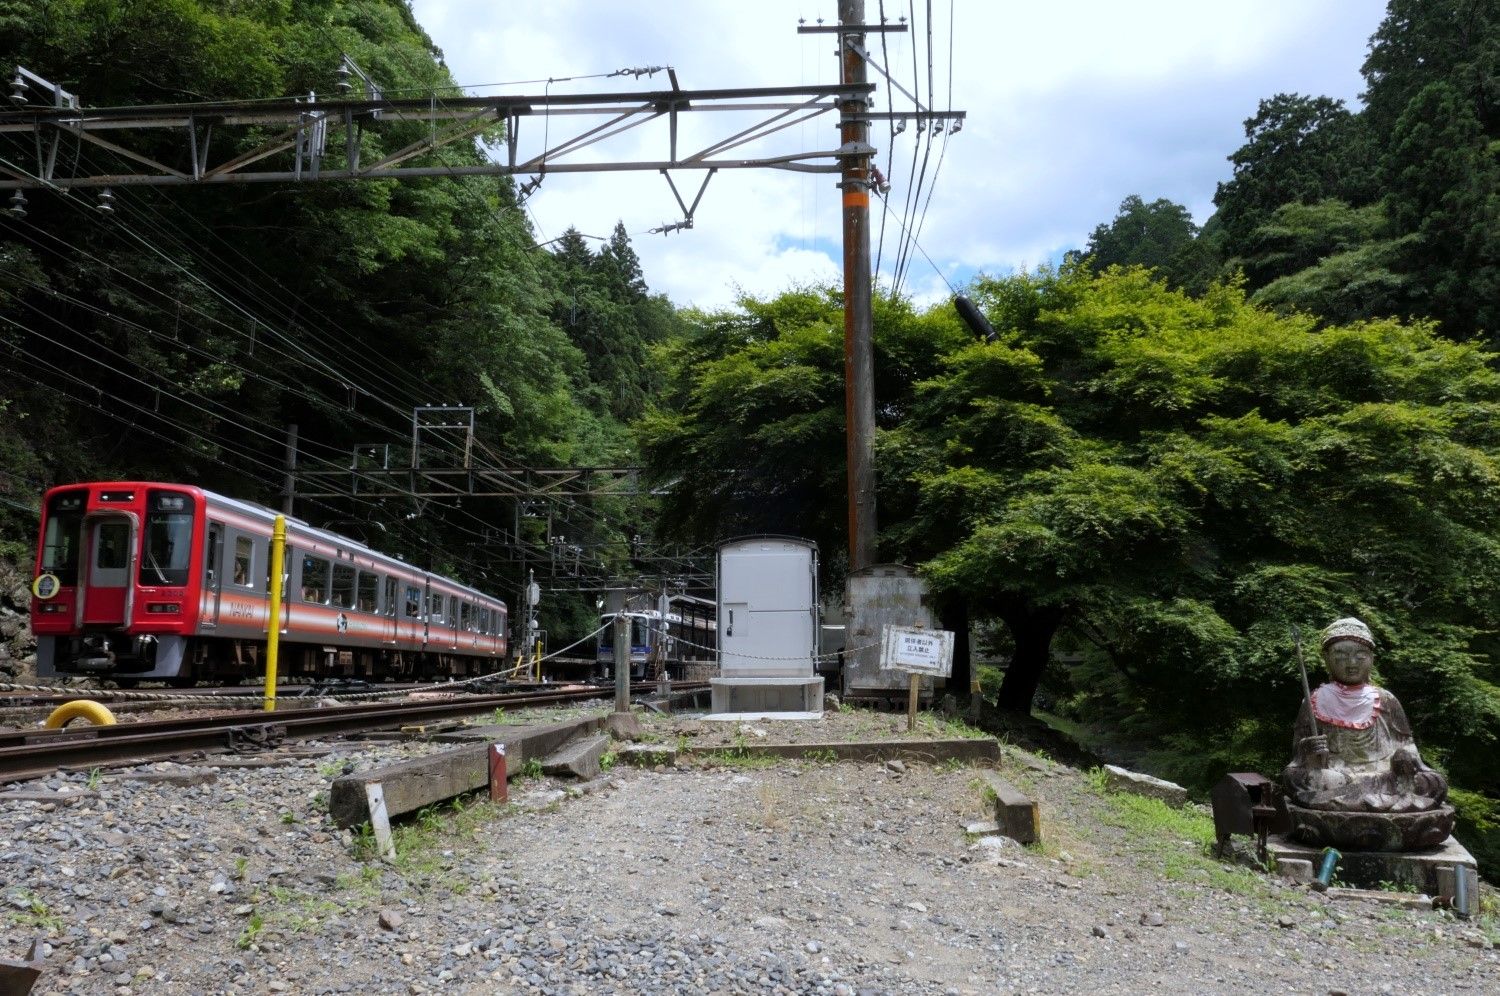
[32,483,204,681]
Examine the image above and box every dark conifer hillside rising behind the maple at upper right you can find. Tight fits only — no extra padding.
[1080,0,1500,341]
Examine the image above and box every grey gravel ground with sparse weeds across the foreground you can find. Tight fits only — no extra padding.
[0,710,1500,996]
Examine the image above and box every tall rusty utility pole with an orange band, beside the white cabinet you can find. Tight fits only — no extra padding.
[839,0,876,570]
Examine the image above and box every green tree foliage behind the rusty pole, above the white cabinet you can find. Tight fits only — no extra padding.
[636,288,971,573]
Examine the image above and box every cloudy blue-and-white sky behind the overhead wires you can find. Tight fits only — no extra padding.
[413,0,1385,308]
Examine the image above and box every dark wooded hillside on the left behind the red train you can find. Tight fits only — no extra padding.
[0,0,674,633]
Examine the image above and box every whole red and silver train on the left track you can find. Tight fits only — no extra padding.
[32,482,509,686]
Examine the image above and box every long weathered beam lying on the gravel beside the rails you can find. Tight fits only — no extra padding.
[329,716,605,827]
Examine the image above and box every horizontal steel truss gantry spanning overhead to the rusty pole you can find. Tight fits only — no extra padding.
[0,68,875,190]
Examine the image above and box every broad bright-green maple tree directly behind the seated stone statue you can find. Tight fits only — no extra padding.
[882,269,1500,804]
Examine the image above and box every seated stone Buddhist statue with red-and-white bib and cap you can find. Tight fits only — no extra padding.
[1283,618,1454,851]
